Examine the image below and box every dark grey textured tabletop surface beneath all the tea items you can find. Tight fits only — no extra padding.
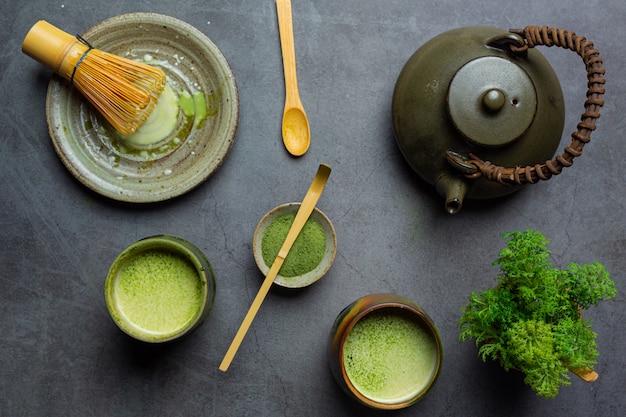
[0,0,626,417]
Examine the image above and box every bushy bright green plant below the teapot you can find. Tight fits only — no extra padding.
[458,229,617,398]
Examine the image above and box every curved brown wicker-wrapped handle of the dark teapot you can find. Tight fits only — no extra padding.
[466,26,605,185]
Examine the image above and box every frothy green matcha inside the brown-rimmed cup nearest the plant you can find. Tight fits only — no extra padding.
[343,308,437,404]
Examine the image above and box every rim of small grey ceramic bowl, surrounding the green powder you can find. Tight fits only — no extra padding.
[252,203,337,288]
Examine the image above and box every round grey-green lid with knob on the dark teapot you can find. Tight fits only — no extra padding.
[447,56,537,147]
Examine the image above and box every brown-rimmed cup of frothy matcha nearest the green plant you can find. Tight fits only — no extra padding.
[329,294,443,410]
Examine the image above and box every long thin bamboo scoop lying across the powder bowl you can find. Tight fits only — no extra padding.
[219,164,330,372]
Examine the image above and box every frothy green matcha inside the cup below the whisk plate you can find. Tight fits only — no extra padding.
[115,250,202,333]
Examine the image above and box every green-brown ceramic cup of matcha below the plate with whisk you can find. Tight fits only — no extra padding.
[104,235,215,343]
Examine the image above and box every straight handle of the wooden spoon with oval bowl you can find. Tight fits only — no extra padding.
[276,0,300,105]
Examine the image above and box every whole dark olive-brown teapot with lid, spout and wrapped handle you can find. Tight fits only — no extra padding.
[392,26,605,214]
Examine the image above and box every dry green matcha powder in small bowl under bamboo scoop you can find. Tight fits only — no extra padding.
[261,213,326,278]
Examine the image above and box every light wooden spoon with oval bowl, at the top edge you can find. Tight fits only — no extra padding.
[276,0,311,156]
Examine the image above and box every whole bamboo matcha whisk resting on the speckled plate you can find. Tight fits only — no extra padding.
[22,20,165,135]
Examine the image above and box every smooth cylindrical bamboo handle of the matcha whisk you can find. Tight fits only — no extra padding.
[22,20,89,81]
